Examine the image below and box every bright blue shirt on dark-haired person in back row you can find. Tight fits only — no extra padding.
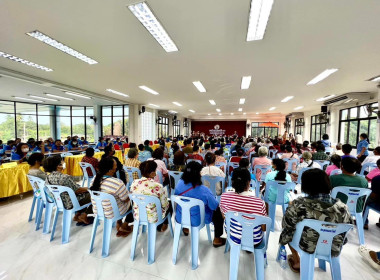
[174,180,219,227]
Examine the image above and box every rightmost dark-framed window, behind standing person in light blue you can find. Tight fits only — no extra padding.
[339,103,378,149]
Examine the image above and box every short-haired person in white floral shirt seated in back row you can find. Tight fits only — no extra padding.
[130,160,173,232]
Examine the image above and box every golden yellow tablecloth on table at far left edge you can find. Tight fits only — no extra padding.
[0,162,32,198]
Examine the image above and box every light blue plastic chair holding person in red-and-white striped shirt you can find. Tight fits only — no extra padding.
[224,212,272,280]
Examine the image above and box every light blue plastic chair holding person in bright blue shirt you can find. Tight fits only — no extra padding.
[170,195,211,269]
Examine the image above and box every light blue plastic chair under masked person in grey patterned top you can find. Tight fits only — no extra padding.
[46,185,91,244]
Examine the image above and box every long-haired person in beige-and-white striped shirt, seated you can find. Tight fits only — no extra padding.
[90,157,133,237]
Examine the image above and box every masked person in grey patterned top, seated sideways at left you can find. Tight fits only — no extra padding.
[43,155,94,225]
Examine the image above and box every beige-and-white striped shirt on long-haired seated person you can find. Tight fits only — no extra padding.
[91,176,131,219]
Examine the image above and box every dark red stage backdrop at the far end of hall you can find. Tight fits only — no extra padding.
[191,121,247,136]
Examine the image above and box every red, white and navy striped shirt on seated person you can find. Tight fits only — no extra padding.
[219,191,269,245]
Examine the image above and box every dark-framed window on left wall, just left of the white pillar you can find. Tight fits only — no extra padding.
[102,105,129,136]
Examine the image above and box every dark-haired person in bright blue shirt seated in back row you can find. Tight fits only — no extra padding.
[174,162,226,247]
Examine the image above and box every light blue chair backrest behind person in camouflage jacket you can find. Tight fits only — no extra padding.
[292,219,353,260]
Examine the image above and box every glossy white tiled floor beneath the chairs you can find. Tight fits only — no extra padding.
[0,192,380,280]
